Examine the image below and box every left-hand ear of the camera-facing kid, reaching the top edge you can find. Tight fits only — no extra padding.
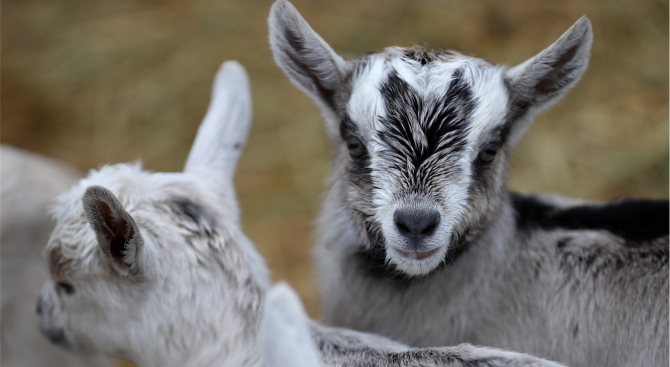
[268,0,349,136]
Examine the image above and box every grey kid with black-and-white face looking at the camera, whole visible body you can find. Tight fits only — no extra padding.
[269,0,668,366]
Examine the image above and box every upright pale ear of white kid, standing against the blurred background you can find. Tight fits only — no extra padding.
[184,61,251,214]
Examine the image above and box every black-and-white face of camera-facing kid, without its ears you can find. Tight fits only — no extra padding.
[340,52,508,275]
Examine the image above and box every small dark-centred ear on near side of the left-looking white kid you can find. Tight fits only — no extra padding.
[82,186,144,276]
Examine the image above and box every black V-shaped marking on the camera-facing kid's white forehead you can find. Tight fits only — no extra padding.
[380,69,475,188]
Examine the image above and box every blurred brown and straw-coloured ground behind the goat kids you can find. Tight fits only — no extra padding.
[1,0,669,356]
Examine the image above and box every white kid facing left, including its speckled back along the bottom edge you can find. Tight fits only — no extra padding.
[38,63,560,367]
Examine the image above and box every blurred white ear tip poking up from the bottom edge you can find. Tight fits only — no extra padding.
[259,283,321,367]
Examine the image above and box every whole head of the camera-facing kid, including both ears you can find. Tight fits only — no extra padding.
[269,0,593,275]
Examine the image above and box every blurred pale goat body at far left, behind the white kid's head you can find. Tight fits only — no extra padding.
[0,145,112,367]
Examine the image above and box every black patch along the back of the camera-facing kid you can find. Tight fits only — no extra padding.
[512,193,670,246]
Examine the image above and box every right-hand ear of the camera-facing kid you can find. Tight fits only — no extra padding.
[507,16,593,147]
